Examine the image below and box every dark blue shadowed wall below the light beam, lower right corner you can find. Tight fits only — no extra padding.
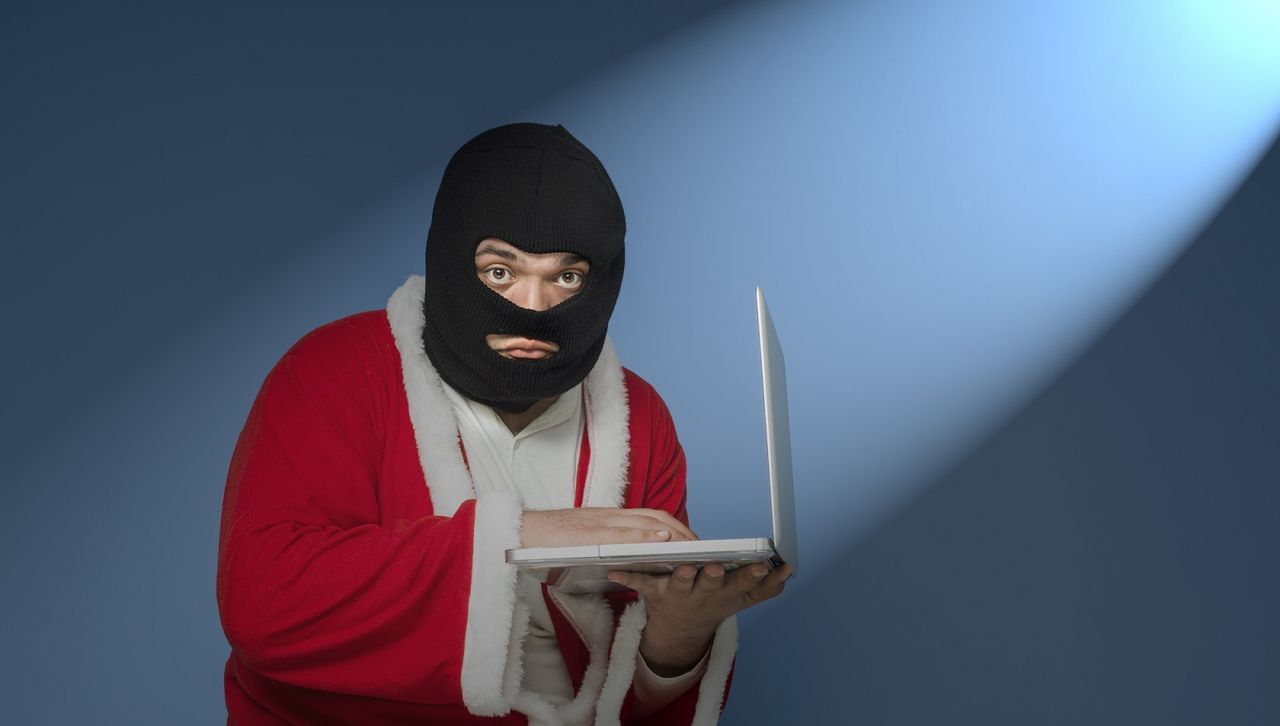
[727,136,1280,725]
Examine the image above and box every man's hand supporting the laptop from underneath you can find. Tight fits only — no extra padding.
[609,563,791,677]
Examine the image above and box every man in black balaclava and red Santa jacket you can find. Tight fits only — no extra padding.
[218,124,788,723]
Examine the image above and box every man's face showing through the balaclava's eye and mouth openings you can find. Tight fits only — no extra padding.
[476,237,591,360]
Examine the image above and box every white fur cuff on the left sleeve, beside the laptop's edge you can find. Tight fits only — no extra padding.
[462,492,529,716]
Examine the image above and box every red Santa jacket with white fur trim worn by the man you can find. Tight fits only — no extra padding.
[218,277,737,725]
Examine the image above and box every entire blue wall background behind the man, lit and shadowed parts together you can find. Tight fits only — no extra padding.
[0,0,1280,725]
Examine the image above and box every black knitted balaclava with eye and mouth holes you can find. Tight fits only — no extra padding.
[422,123,626,412]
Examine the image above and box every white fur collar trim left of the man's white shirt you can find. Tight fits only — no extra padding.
[387,275,476,517]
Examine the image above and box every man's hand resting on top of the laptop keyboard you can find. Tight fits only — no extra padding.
[520,507,698,547]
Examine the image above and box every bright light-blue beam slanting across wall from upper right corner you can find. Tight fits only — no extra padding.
[160,0,1280,572]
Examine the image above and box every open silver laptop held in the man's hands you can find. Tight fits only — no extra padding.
[507,288,800,593]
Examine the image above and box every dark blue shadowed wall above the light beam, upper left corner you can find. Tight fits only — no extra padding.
[0,0,724,458]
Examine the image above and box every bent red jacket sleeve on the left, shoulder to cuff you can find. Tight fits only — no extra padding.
[218,324,520,708]
